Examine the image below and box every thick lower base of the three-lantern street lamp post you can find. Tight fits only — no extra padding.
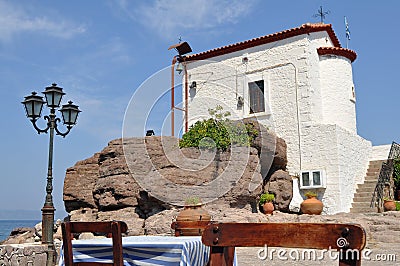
[42,206,56,266]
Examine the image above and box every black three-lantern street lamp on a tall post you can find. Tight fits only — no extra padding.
[22,83,81,266]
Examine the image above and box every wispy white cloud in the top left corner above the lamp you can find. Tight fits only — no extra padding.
[0,0,86,41]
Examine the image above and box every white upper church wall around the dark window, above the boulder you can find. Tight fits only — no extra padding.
[184,33,318,172]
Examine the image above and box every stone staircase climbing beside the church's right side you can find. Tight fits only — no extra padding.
[350,160,384,213]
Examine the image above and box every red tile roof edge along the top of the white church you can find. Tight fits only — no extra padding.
[184,23,355,61]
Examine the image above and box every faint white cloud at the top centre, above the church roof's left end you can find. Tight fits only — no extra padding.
[117,0,257,38]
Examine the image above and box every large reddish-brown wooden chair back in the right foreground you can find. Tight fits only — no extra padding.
[202,223,366,266]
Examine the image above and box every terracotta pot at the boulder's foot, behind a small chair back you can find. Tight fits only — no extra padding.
[176,204,211,236]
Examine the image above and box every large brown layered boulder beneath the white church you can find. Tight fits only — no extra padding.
[64,121,292,235]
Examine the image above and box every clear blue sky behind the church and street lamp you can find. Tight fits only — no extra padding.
[0,0,400,218]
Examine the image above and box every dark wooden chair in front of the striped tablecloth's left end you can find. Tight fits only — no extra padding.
[61,221,128,266]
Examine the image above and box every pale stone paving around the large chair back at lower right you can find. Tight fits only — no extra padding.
[230,212,400,266]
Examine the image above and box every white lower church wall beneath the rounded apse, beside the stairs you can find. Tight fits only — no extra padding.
[300,124,372,214]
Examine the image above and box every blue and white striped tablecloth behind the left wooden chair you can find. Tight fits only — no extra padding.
[59,236,210,266]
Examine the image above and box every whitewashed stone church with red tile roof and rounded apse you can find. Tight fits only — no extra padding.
[177,23,390,214]
